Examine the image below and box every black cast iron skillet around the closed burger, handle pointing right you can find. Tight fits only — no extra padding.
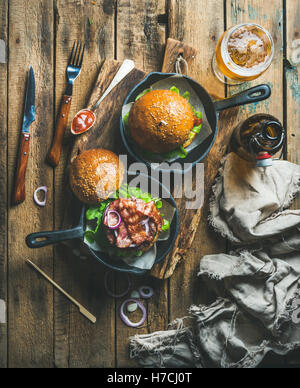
[120,72,271,173]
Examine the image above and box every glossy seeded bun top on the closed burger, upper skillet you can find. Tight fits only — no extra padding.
[128,90,194,153]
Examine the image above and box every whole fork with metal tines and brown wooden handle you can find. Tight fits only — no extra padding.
[47,42,85,167]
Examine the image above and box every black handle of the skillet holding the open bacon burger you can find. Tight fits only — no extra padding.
[26,226,84,248]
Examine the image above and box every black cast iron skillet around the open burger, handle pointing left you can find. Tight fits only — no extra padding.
[26,172,179,275]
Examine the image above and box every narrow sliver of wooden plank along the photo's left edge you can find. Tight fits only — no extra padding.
[0,0,8,369]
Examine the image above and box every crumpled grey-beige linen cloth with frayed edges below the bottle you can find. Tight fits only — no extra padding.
[130,153,300,368]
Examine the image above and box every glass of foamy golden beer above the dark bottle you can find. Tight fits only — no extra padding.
[212,23,274,85]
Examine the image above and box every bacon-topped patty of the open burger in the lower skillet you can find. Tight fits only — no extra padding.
[104,198,163,249]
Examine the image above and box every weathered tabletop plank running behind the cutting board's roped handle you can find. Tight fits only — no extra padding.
[168,0,225,321]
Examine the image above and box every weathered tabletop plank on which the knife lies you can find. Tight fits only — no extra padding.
[8,0,53,368]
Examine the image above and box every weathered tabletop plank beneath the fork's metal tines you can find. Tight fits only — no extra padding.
[53,0,115,367]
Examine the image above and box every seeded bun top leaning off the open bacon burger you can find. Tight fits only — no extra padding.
[69,149,125,205]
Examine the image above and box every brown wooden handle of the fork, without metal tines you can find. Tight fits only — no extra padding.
[47,96,72,167]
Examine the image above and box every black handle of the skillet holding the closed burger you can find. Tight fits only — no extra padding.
[214,84,271,112]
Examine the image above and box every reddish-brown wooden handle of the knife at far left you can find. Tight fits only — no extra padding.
[12,133,30,205]
